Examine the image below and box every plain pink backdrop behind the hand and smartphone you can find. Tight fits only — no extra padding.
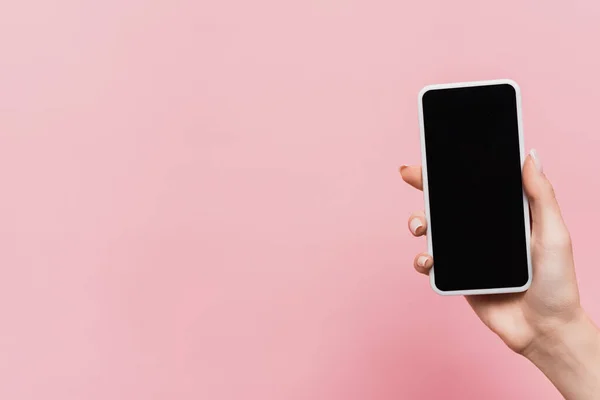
[0,0,600,400]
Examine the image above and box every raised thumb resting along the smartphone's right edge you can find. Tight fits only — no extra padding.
[523,150,570,248]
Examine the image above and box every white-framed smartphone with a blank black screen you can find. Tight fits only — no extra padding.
[419,79,532,295]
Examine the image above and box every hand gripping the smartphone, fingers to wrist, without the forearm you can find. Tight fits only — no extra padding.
[400,151,582,354]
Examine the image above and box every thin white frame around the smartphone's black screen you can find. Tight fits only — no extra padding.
[419,79,533,296]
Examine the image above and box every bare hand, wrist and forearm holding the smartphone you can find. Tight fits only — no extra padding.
[400,150,600,399]
